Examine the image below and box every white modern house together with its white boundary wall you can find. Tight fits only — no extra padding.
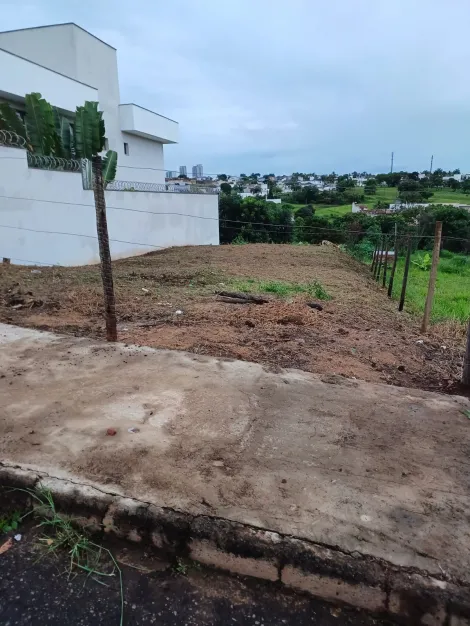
[0,24,219,265]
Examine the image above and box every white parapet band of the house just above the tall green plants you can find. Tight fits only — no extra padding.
[0,49,98,113]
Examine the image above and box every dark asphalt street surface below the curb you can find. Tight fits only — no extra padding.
[0,529,396,626]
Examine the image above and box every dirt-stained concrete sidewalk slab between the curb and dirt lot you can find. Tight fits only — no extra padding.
[0,325,470,581]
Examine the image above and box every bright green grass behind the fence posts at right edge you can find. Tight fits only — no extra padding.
[393,251,470,322]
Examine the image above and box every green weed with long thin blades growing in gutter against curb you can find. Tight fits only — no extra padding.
[17,489,124,626]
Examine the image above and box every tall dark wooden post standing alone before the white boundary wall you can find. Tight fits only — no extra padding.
[92,156,117,341]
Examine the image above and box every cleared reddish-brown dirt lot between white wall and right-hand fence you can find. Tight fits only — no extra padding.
[0,244,463,393]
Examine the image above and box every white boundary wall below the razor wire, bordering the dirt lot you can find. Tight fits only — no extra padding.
[0,147,219,265]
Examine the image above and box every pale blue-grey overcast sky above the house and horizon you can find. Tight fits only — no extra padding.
[0,0,470,174]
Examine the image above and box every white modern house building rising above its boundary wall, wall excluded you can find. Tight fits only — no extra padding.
[0,23,178,183]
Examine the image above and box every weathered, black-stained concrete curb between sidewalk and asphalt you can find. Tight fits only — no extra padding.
[0,463,470,626]
